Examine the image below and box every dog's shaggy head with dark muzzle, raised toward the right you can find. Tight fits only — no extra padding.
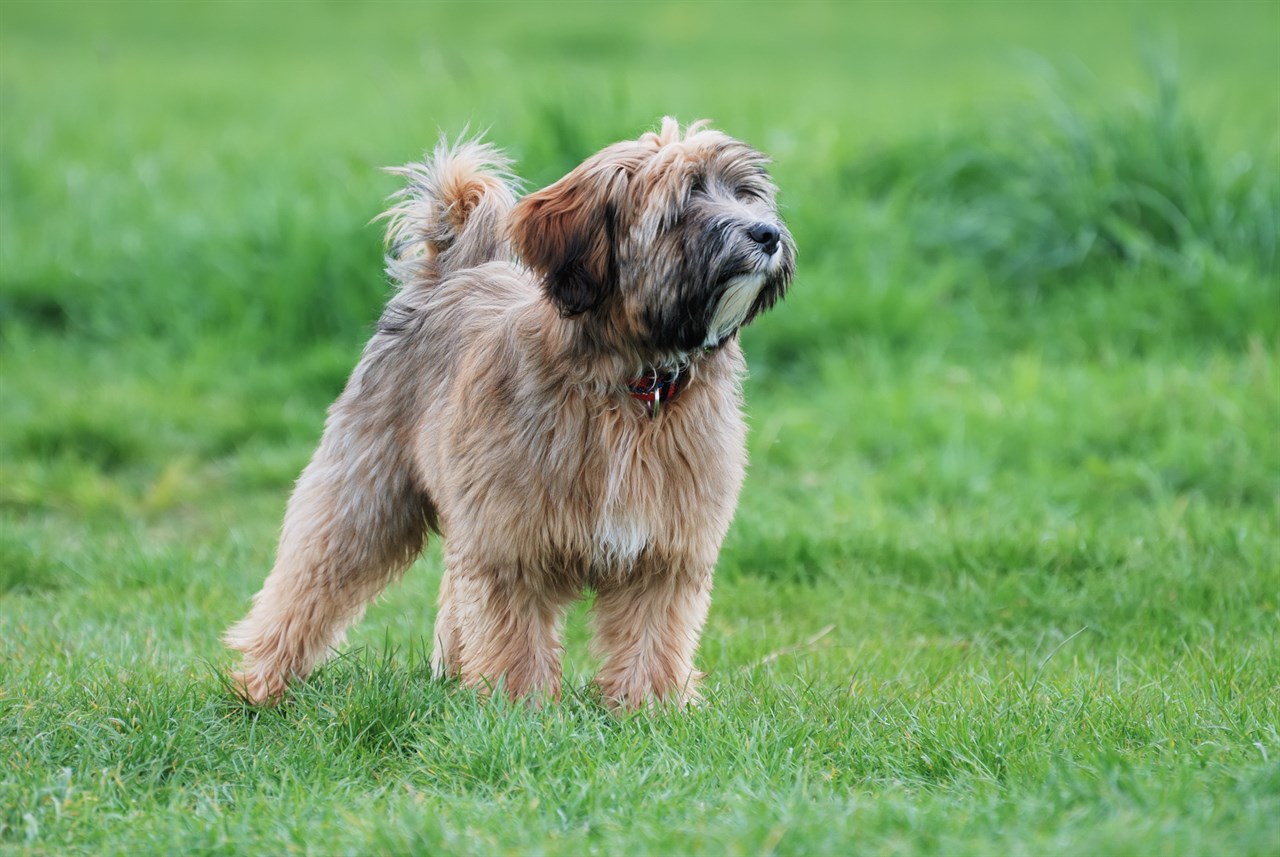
[511,118,795,362]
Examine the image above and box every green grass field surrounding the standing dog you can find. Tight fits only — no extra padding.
[0,1,1280,856]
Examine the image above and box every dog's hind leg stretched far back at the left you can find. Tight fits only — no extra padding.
[224,414,430,702]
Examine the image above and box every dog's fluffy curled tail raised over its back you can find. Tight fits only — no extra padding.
[381,136,517,288]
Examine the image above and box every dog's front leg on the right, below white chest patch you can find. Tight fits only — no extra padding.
[593,568,712,709]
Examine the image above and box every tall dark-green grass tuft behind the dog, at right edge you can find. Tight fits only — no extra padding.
[845,61,1280,293]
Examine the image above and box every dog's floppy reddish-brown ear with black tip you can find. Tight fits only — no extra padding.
[511,162,627,316]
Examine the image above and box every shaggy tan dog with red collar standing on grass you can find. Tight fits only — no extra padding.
[225,118,796,709]
